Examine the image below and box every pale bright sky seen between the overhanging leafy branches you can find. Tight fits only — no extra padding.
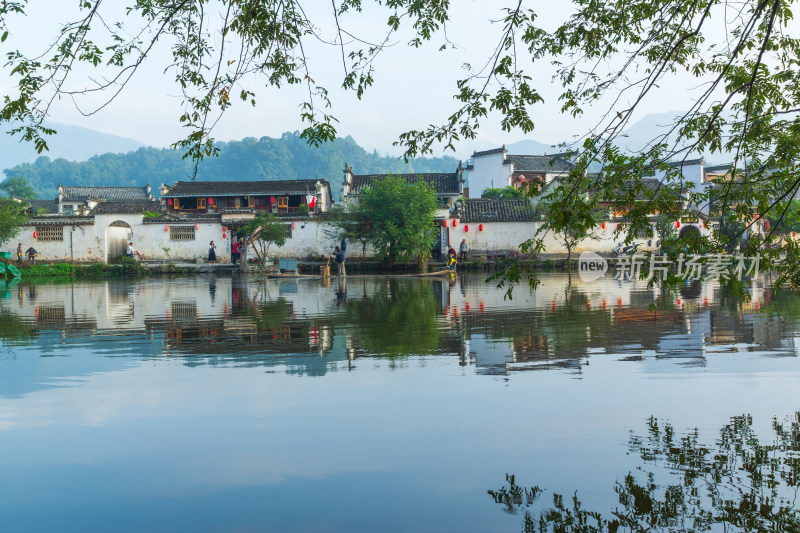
[0,0,712,155]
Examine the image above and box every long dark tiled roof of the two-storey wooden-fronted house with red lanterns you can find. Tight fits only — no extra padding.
[162,180,328,198]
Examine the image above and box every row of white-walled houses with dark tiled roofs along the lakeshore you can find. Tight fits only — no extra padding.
[18,148,721,262]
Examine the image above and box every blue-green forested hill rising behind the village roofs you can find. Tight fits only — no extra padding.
[3,133,458,200]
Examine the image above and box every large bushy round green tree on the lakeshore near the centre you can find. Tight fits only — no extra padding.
[357,176,436,264]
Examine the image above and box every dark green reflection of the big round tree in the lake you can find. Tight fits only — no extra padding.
[346,280,440,356]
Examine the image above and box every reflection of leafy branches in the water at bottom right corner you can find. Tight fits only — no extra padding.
[488,412,800,533]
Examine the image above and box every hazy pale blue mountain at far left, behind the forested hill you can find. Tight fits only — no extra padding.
[0,123,146,168]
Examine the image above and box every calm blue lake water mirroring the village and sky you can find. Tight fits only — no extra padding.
[0,274,800,532]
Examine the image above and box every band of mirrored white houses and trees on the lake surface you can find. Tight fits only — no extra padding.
[0,275,797,386]
